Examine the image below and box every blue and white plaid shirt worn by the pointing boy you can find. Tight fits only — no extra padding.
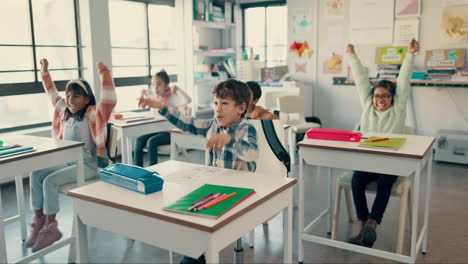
[160,106,258,171]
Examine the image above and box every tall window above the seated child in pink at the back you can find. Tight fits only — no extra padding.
[109,0,178,111]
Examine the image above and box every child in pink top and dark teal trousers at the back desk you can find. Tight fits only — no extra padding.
[133,70,191,167]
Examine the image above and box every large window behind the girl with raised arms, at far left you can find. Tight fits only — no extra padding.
[0,0,82,132]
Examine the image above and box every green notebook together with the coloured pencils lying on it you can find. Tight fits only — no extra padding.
[164,184,255,219]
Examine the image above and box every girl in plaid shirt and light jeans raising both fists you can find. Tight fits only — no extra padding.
[24,59,117,252]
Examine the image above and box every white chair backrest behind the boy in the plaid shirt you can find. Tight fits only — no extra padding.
[249,119,287,177]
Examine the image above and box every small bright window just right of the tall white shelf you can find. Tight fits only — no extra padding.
[242,4,288,67]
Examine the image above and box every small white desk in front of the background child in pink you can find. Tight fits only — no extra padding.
[110,112,174,164]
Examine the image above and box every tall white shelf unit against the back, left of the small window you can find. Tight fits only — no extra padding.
[184,0,242,117]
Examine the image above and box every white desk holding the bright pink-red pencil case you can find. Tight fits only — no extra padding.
[298,133,435,263]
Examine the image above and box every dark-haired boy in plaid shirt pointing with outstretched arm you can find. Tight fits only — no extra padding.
[139,79,258,264]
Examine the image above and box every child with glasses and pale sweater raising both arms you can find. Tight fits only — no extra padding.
[347,39,419,247]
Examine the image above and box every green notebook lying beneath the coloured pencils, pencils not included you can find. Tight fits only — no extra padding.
[164,184,255,219]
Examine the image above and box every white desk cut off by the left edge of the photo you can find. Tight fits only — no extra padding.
[0,135,84,263]
